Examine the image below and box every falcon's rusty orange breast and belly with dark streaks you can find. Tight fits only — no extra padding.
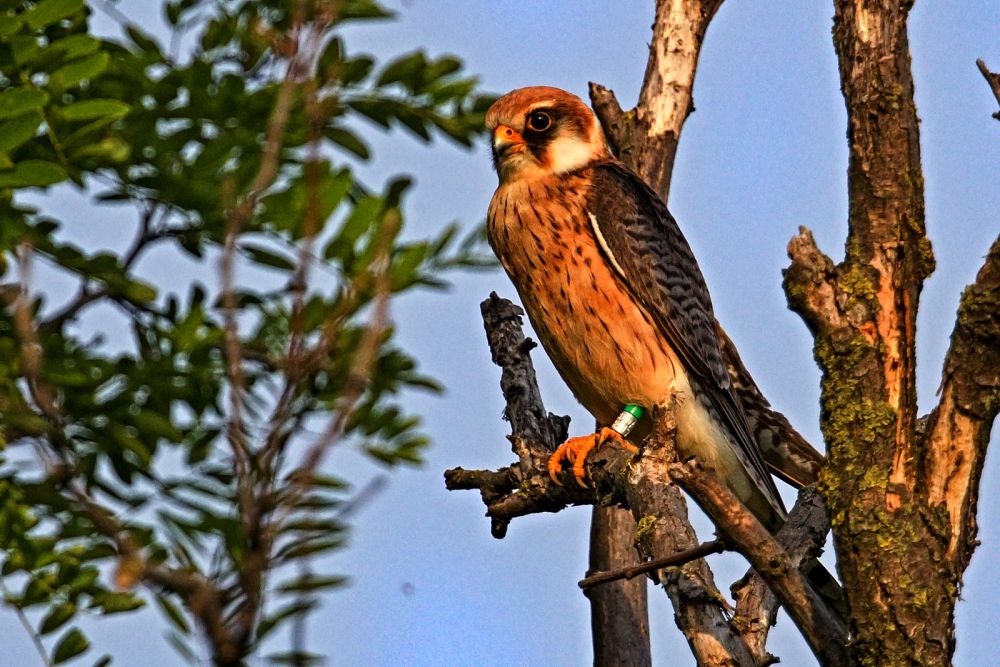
[487,171,679,424]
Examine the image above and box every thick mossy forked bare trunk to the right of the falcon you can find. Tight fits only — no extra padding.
[785,0,1000,665]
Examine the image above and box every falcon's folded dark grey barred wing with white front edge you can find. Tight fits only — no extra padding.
[587,160,785,516]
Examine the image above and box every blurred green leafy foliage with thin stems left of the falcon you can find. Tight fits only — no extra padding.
[0,0,491,664]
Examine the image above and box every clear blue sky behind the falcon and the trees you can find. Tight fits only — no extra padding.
[7,0,1000,666]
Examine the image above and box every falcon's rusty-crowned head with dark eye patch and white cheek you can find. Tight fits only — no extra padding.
[486,86,610,183]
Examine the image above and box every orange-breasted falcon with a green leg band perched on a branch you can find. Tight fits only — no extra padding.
[486,86,822,529]
